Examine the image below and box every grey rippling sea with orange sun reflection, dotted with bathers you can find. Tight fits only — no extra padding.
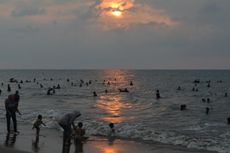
[0,69,230,153]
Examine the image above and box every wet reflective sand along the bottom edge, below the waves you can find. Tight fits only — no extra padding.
[0,126,217,153]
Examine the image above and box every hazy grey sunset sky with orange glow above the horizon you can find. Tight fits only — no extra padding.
[0,0,230,69]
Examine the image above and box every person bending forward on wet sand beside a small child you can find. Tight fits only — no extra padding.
[58,111,81,153]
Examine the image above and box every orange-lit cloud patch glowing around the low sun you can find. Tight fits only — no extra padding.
[96,0,178,30]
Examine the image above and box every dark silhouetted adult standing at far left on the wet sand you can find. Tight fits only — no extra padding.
[5,92,21,133]
